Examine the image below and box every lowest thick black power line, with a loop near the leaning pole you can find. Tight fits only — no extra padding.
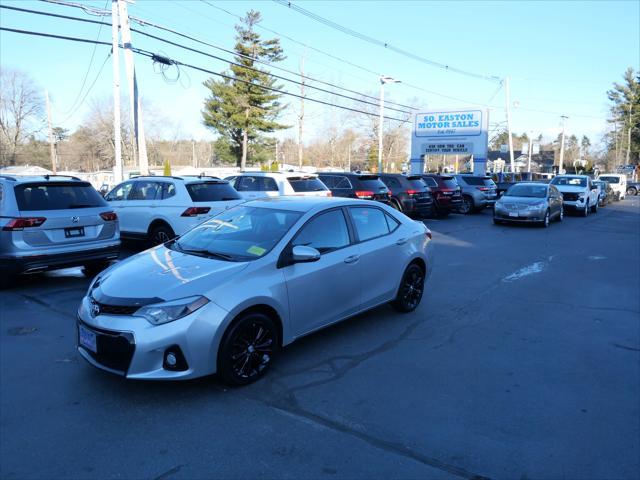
[0,26,409,123]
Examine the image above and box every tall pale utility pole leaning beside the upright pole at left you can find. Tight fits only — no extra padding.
[117,0,149,175]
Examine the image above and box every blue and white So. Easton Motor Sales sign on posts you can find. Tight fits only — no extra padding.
[411,108,489,175]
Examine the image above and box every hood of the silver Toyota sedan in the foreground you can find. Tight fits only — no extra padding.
[93,245,249,305]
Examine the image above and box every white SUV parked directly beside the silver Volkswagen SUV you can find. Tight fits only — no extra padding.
[105,176,243,245]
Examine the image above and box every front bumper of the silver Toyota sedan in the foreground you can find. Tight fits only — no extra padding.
[76,297,228,380]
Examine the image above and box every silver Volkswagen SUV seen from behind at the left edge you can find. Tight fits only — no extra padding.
[0,175,120,286]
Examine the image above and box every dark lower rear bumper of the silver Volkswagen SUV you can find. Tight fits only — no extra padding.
[0,240,120,274]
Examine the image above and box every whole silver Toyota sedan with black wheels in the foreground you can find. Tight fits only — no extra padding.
[78,197,432,385]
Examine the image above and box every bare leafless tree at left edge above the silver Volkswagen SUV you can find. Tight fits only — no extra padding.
[0,69,44,165]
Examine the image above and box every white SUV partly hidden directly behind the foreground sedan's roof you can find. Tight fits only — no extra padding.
[226,172,331,200]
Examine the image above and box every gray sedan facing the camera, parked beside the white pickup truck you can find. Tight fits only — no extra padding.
[493,182,564,227]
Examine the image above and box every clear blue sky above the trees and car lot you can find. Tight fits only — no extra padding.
[0,0,640,148]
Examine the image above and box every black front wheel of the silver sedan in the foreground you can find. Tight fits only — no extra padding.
[217,312,280,387]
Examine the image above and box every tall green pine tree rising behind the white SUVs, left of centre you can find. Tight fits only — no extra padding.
[202,10,287,168]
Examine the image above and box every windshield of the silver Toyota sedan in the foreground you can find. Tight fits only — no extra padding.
[167,206,302,262]
